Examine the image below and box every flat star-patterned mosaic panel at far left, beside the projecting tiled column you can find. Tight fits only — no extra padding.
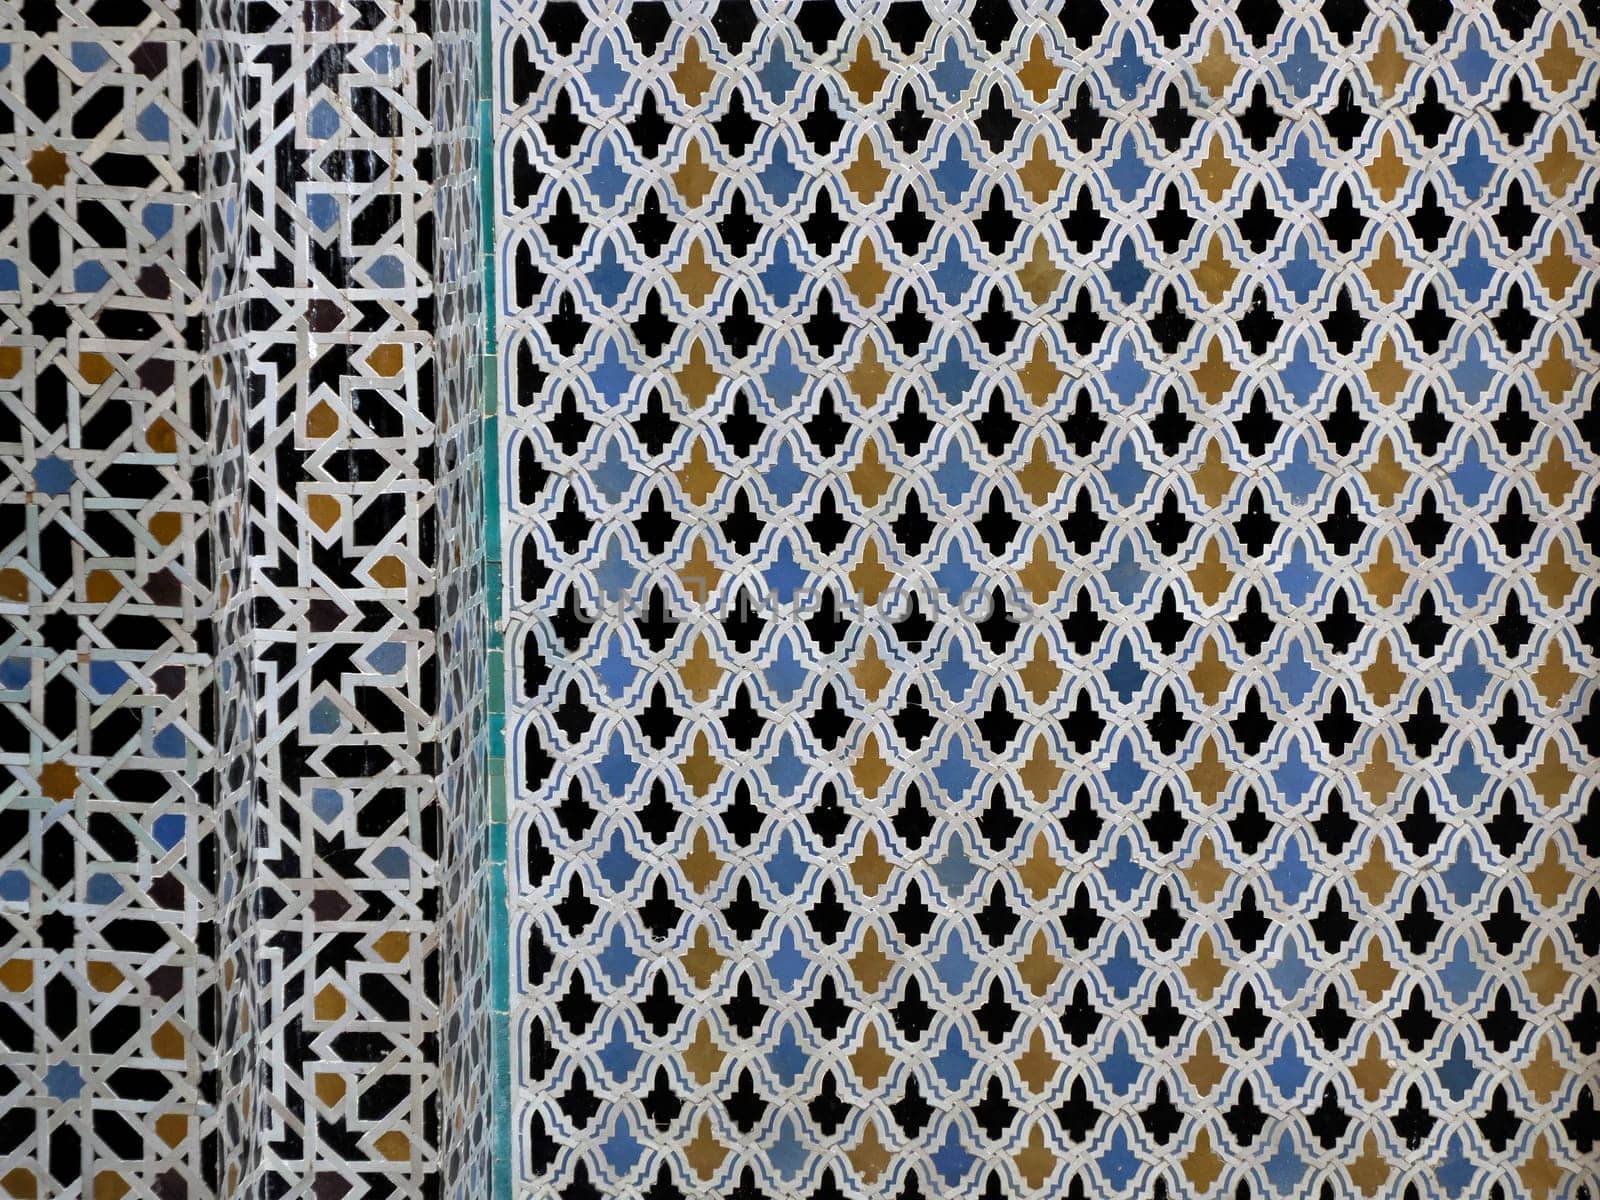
[0,0,218,1197]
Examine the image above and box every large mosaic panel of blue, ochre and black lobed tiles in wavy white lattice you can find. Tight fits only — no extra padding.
[493,0,1600,1200]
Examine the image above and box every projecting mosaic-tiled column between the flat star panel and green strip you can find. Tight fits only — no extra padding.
[206,0,490,1200]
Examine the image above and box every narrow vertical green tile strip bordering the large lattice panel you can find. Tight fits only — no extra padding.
[478,0,512,1200]
